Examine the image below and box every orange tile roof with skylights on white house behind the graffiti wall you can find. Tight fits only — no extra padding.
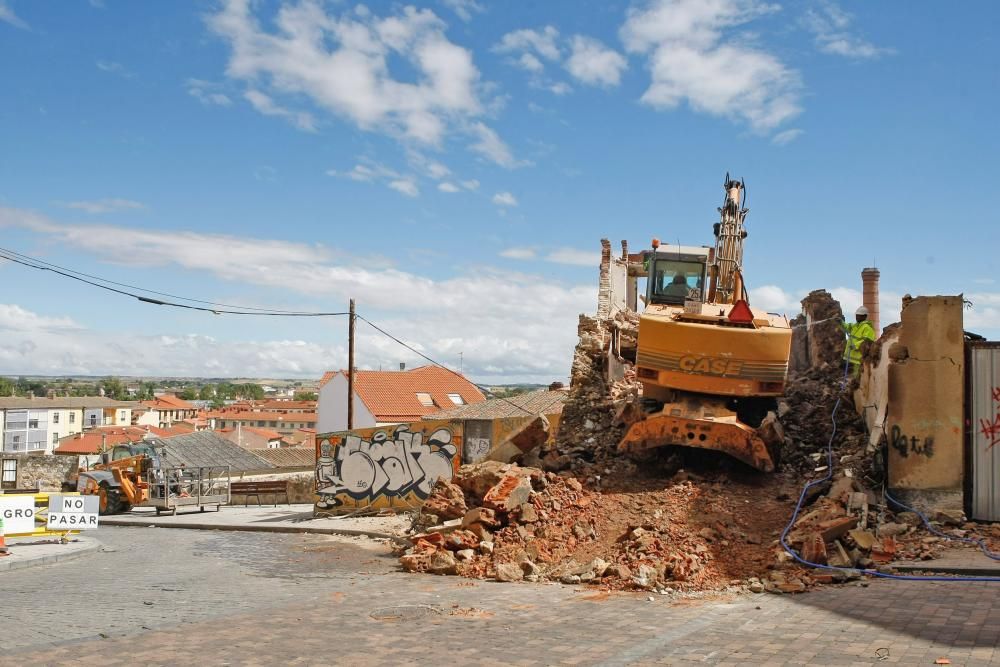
[324,366,486,422]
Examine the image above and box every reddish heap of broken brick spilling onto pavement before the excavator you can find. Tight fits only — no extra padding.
[400,462,789,590]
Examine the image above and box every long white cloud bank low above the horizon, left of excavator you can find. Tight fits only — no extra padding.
[0,208,596,382]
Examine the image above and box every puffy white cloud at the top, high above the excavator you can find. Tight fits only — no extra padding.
[621,0,801,131]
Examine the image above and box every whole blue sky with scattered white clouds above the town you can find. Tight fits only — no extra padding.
[0,0,1000,382]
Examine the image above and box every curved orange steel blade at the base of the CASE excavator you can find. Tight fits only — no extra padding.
[618,403,775,472]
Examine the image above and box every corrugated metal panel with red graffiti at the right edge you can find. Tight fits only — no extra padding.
[968,343,1000,521]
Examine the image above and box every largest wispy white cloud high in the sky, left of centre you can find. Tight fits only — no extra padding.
[208,0,516,165]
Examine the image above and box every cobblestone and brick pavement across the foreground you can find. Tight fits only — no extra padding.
[0,528,1000,666]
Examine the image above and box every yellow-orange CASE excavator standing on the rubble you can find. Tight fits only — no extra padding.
[618,174,792,472]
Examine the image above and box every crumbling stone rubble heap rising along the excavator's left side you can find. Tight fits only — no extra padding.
[543,311,640,474]
